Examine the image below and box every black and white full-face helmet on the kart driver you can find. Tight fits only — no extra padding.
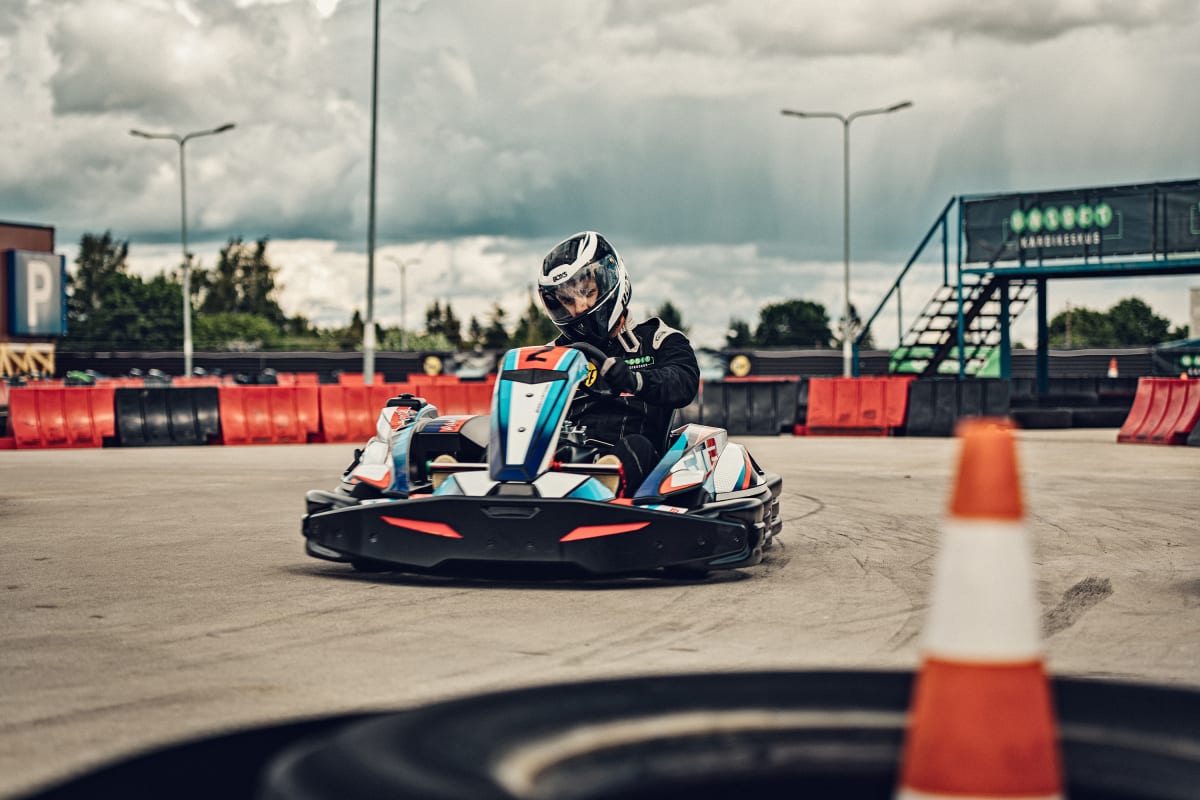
[538,230,632,344]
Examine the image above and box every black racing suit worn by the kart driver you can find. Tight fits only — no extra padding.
[554,317,700,461]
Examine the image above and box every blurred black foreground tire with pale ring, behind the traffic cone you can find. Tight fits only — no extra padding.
[259,672,1200,800]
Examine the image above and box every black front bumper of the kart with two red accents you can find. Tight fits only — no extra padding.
[302,497,764,575]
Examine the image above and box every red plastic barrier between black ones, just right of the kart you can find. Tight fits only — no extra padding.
[806,378,907,437]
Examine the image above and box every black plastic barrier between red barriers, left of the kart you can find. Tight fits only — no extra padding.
[113,386,221,447]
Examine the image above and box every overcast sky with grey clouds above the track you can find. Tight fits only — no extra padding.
[0,0,1200,345]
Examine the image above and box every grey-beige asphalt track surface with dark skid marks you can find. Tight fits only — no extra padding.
[0,429,1200,796]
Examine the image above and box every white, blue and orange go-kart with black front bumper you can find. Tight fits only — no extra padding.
[302,345,782,575]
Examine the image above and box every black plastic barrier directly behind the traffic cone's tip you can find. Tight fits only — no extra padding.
[904,378,1012,437]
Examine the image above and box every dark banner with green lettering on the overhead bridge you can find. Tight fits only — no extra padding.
[962,180,1200,264]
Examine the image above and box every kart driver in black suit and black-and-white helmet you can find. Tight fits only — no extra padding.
[538,230,700,494]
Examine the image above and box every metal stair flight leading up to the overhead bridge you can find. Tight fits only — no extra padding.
[888,275,1036,378]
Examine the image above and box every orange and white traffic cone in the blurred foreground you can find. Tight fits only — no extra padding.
[896,420,1063,800]
